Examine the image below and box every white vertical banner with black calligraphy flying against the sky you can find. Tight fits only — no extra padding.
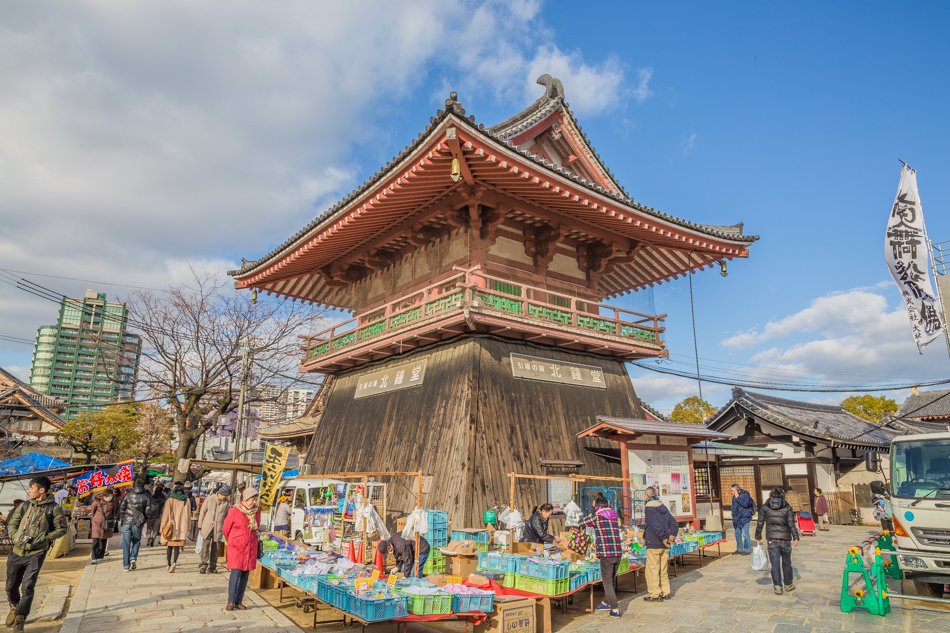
[884,165,944,354]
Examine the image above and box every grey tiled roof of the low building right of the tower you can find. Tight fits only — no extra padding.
[706,387,901,447]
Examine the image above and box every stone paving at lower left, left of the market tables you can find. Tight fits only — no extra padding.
[61,546,300,633]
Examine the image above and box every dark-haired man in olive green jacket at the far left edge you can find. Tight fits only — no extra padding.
[6,477,66,631]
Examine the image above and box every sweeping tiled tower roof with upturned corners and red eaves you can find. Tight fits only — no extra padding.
[229,77,758,305]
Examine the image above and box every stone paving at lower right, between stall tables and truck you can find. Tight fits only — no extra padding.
[555,526,950,633]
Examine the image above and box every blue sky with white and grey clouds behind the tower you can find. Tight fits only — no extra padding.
[0,1,950,410]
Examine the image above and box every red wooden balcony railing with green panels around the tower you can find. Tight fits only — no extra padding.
[302,268,666,362]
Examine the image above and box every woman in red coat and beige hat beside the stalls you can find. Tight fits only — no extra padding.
[221,488,261,611]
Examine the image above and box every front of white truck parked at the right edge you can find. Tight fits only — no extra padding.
[890,432,950,598]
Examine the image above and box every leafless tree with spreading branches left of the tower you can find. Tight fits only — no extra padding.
[129,274,320,459]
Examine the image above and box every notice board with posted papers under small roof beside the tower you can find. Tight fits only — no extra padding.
[627,447,695,518]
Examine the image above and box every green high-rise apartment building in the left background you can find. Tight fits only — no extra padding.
[30,290,142,419]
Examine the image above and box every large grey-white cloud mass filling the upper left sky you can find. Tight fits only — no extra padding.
[0,0,649,364]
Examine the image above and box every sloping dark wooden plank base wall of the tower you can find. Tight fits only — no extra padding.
[307,336,642,527]
